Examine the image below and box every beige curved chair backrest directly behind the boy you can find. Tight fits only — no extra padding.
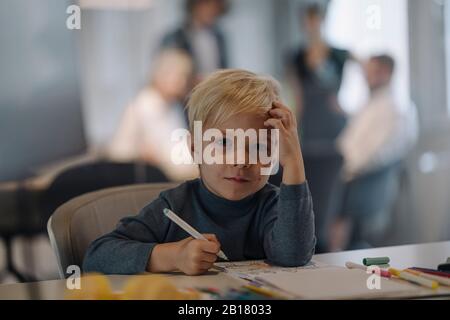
[47,183,178,279]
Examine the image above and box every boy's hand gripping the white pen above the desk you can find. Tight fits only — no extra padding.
[175,234,220,275]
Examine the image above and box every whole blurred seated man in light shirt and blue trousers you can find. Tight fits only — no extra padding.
[332,54,417,250]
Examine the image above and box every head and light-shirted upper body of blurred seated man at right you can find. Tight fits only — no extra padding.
[338,55,416,180]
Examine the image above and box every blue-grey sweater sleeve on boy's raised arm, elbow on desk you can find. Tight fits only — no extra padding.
[263,182,316,267]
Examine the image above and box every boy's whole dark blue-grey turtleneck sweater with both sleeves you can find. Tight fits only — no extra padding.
[83,179,316,274]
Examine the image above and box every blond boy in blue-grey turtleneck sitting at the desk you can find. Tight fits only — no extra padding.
[83,70,316,275]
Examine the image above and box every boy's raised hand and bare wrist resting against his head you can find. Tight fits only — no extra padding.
[264,102,305,184]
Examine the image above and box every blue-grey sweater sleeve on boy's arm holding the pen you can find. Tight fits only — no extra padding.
[83,197,168,274]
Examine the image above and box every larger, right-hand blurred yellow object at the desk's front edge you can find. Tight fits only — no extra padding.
[121,275,200,300]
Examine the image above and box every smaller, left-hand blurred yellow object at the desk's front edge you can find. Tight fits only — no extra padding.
[65,273,117,300]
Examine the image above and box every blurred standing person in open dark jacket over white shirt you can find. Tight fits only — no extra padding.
[162,0,229,84]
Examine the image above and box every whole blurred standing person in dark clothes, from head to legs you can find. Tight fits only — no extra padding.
[287,3,351,253]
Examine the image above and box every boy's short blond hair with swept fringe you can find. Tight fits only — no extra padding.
[187,69,280,132]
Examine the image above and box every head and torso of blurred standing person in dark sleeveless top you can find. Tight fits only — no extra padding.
[290,4,350,148]
